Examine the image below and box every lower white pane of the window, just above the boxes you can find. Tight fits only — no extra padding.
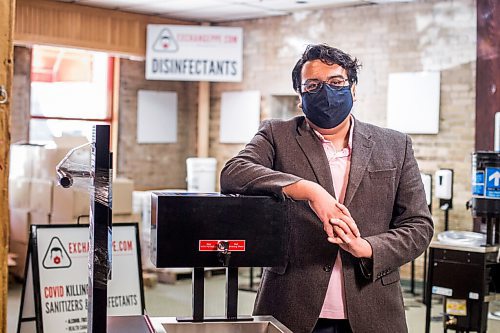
[30,119,109,144]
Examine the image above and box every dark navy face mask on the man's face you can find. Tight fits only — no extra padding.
[302,84,353,129]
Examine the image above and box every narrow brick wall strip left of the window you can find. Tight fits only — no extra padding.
[10,46,31,143]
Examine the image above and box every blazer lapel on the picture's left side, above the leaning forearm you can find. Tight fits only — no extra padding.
[296,118,335,196]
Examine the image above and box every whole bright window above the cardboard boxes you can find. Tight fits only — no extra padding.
[29,46,113,143]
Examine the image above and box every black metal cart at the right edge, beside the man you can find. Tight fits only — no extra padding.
[425,242,500,333]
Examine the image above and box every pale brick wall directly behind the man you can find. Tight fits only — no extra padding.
[210,0,476,276]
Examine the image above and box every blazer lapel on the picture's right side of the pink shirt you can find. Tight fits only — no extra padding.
[344,119,374,206]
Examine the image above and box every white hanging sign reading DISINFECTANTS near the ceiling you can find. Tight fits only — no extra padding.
[146,24,243,82]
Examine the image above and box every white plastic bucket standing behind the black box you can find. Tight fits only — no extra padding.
[186,157,217,192]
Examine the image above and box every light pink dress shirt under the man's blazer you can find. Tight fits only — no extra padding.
[315,122,354,319]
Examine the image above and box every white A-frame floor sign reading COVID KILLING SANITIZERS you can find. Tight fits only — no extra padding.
[19,224,143,333]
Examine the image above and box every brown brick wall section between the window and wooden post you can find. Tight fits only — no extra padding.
[117,59,198,189]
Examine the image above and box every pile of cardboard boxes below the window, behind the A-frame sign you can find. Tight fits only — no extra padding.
[9,137,137,278]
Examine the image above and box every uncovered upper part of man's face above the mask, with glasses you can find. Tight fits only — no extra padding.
[300,59,356,100]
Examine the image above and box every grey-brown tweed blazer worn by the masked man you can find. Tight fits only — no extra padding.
[220,116,433,333]
